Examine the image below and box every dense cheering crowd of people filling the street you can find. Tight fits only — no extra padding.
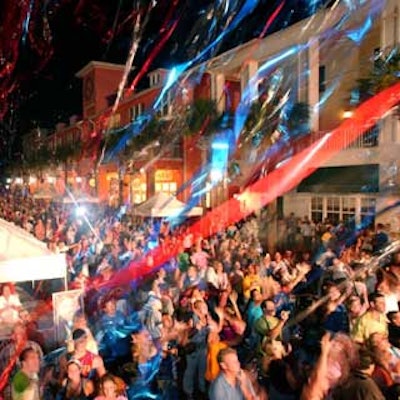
[0,191,400,400]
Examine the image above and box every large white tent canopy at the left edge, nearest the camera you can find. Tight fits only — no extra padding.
[0,219,67,284]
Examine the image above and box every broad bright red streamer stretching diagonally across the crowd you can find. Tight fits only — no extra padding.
[109,83,400,286]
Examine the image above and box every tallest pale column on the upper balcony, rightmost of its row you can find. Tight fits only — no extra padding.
[305,38,320,132]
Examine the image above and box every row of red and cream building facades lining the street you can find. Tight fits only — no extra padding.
[14,0,400,231]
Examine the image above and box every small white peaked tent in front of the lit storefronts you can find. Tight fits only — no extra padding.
[135,192,203,217]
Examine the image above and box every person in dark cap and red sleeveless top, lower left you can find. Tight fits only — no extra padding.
[64,328,106,378]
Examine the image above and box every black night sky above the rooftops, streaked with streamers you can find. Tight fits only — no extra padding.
[0,0,332,159]
